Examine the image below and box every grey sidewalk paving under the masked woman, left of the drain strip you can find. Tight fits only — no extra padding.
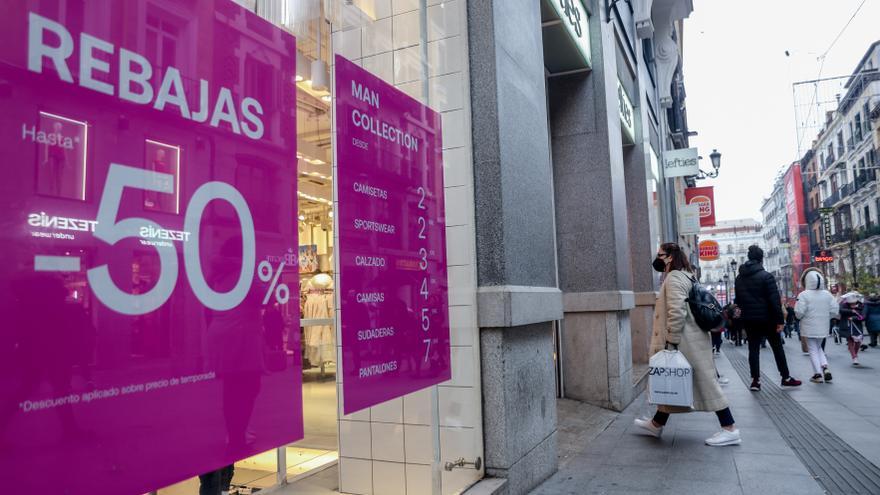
[533,346,824,495]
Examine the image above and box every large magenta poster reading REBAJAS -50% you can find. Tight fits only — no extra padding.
[0,0,303,495]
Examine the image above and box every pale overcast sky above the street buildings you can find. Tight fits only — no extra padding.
[683,0,880,220]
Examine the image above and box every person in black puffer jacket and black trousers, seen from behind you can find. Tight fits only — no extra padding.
[735,245,801,392]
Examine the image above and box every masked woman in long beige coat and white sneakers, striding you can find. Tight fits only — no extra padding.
[635,243,742,447]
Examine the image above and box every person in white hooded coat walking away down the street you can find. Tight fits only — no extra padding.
[794,268,840,383]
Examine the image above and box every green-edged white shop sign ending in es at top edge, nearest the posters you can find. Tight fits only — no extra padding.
[541,0,592,74]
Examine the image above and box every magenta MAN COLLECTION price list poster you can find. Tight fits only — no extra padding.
[336,56,450,414]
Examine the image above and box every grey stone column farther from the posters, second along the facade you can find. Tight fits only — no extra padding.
[549,7,635,410]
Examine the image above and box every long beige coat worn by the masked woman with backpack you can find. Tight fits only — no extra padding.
[651,270,728,412]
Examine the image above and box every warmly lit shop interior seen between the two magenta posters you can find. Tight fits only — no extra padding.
[157,2,339,495]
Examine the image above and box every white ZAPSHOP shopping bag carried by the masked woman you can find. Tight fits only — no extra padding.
[648,350,694,407]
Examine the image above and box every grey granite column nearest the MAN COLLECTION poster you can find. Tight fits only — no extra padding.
[467,0,562,495]
